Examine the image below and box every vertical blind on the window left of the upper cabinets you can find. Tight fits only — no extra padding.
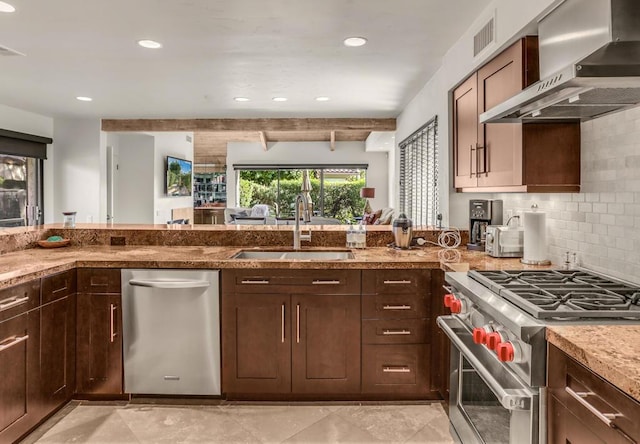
[400,116,440,225]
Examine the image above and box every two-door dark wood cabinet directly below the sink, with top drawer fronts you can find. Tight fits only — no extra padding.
[222,270,360,398]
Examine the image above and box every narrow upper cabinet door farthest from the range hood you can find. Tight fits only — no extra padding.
[453,73,478,188]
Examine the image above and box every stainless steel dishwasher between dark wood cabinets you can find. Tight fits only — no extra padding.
[122,269,221,395]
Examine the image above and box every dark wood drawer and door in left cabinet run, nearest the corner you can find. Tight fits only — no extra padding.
[40,270,76,416]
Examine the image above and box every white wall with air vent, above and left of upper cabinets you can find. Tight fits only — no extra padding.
[394,0,561,229]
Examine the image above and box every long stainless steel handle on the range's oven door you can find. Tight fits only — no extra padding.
[437,316,533,410]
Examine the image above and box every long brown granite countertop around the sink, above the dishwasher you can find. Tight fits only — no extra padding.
[0,245,548,288]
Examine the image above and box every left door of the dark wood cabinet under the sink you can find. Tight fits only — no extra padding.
[222,293,291,393]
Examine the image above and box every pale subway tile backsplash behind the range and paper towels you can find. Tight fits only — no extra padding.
[495,107,640,283]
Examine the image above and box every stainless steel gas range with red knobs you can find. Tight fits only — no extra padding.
[438,270,640,444]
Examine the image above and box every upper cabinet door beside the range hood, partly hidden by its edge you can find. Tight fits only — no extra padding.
[477,38,537,187]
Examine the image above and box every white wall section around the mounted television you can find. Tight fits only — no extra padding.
[152,133,193,224]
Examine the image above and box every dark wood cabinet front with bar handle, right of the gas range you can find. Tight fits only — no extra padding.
[547,345,640,444]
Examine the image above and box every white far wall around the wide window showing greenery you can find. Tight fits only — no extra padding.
[227,142,389,209]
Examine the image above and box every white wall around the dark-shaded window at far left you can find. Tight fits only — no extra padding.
[0,105,55,223]
